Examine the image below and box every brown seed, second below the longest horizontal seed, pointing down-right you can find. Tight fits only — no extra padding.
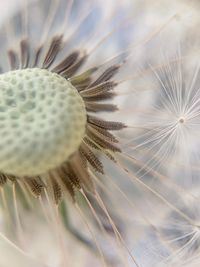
[86,128,121,152]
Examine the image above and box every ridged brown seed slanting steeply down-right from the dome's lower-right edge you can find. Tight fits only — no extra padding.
[79,143,104,174]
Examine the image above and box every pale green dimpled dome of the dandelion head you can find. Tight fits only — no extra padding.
[0,68,86,176]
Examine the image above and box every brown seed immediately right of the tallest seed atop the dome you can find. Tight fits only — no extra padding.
[52,51,80,73]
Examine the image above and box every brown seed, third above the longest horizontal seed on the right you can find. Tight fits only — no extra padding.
[80,81,117,97]
